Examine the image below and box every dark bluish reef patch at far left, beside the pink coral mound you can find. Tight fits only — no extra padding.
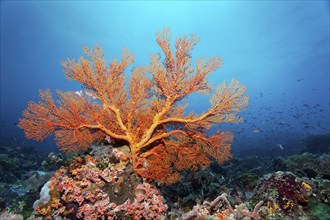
[0,137,53,219]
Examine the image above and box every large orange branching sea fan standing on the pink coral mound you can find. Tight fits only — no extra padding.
[19,28,248,184]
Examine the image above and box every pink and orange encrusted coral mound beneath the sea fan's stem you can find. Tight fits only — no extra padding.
[34,148,167,220]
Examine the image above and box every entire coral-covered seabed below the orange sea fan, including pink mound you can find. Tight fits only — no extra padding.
[0,141,330,220]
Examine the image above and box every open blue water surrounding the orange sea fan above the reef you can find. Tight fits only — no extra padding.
[1,1,330,151]
